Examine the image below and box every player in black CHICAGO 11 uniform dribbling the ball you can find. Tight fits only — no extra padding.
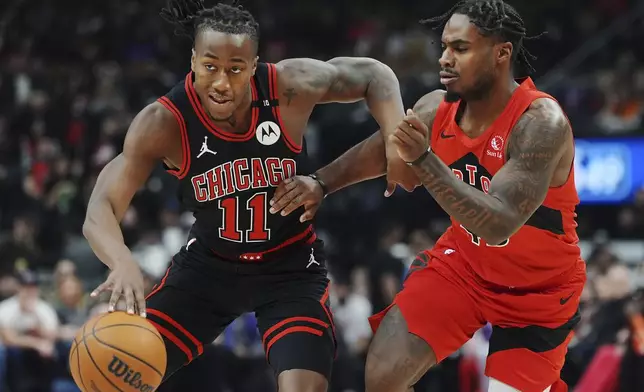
[83,0,417,392]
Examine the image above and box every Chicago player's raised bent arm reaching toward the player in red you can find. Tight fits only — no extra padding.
[277,57,419,192]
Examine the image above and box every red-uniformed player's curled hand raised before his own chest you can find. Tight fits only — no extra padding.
[390,109,429,162]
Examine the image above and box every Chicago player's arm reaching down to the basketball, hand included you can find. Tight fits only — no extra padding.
[83,103,181,316]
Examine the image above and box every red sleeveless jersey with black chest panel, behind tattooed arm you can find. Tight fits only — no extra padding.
[431,78,583,287]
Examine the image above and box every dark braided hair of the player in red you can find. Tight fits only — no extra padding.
[420,0,545,73]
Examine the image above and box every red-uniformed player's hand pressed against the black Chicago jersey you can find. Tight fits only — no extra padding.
[269,176,324,222]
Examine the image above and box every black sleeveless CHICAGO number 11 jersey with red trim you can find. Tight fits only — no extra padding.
[158,63,315,262]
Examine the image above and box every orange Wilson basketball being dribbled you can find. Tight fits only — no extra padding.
[69,312,167,392]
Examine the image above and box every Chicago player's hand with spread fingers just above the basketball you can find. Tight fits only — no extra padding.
[91,260,145,317]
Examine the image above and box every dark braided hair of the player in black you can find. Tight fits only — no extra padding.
[161,0,259,48]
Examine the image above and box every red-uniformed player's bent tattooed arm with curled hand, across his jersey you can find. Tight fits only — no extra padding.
[393,99,572,245]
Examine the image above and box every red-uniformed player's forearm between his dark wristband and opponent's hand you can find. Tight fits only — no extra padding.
[316,133,387,193]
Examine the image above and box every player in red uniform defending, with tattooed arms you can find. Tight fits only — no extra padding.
[273,0,586,392]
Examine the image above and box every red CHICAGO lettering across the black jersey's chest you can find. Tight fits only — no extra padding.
[191,157,297,203]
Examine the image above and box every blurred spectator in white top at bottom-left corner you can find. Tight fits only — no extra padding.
[0,271,58,392]
